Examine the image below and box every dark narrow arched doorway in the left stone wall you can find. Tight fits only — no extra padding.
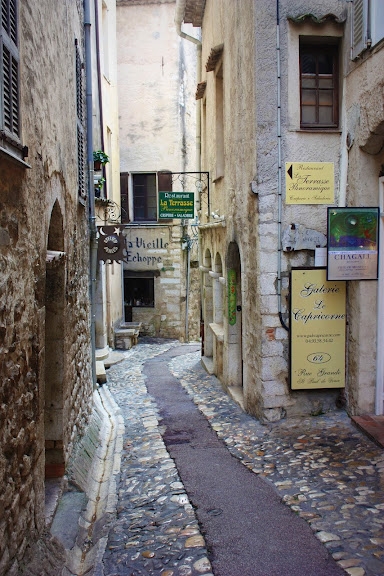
[44,201,65,478]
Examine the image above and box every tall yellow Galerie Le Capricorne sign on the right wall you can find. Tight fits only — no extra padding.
[290,268,346,390]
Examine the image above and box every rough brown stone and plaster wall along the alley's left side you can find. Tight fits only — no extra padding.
[0,0,92,575]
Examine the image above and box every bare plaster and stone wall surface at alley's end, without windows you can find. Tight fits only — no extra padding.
[117,1,200,339]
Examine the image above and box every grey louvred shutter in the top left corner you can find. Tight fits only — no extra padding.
[1,0,20,144]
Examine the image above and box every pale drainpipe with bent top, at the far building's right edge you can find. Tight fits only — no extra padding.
[175,0,201,342]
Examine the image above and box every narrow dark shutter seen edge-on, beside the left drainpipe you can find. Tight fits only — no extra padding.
[75,40,87,202]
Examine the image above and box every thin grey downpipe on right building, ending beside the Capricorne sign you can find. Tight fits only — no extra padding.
[276,0,289,331]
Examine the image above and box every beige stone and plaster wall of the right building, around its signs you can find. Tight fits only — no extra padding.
[198,0,352,421]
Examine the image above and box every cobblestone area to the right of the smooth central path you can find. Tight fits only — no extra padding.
[170,346,384,576]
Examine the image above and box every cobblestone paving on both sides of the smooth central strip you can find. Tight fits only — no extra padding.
[103,341,384,576]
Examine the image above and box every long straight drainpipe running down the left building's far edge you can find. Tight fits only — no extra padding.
[84,0,97,388]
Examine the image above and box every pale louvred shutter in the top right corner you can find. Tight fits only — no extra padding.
[351,0,384,60]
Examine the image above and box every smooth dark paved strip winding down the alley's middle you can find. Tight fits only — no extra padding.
[144,347,344,576]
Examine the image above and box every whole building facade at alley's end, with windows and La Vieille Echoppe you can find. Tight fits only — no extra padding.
[117,0,200,340]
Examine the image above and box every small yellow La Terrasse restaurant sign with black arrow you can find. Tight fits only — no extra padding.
[285,162,335,204]
